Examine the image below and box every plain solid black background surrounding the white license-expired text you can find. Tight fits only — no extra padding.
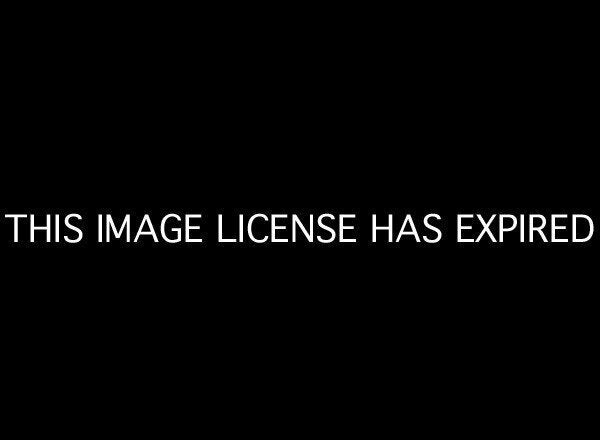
[1,5,598,433]
